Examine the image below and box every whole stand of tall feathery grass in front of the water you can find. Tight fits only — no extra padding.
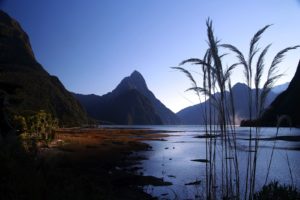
[174,20,300,200]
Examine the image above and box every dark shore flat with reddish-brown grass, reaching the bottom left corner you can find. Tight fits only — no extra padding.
[0,129,170,200]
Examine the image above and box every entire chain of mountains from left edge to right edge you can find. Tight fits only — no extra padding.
[0,10,300,126]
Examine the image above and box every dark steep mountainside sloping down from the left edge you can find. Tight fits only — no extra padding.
[0,10,87,126]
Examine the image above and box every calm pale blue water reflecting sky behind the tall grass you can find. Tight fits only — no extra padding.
[109,126,300,199]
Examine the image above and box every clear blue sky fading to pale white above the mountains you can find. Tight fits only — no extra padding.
[0,0,300,112]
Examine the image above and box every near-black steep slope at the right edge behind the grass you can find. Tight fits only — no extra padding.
[241,60,300,127]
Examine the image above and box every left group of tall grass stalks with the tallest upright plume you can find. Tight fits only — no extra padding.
[178,20,238,199]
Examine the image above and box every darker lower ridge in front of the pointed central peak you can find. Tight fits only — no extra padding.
[74,89,162,125]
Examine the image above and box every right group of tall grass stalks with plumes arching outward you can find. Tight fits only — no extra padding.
[222,25,299,199]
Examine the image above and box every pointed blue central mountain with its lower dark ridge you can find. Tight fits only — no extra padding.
[74,71,180,124]
